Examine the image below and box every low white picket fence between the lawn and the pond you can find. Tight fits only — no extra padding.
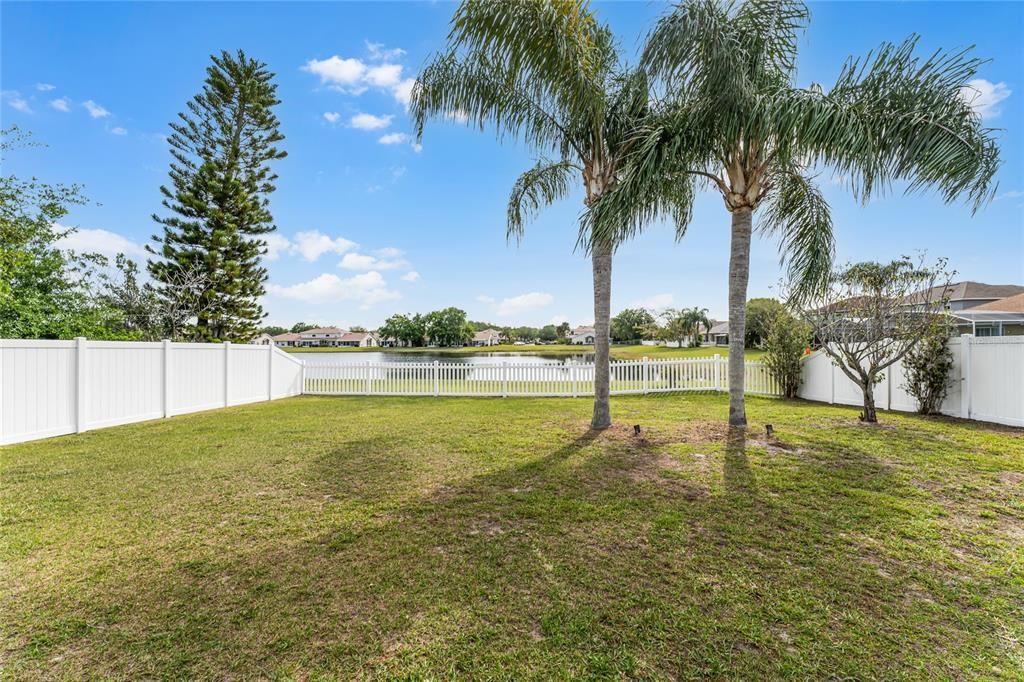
[303,355,780,397]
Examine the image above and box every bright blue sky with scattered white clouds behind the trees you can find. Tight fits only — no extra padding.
[0,2,1024,327]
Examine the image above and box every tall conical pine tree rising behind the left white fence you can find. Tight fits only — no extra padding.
[146,50,287,341]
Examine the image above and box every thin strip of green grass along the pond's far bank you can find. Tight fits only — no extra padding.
[282,343,764,359]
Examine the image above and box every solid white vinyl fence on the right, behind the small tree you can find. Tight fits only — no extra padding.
[798,334,1024,426]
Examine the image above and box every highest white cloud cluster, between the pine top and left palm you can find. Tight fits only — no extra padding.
[302,41,423,153]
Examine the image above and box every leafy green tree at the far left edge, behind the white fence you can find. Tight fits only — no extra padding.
[0,127,109,339]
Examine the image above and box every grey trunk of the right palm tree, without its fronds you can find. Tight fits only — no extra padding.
[729,209,752,426]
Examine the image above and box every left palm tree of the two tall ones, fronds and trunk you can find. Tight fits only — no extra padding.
[411,0,689,428]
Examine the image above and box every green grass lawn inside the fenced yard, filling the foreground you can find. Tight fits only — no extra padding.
[0,394,1024,680]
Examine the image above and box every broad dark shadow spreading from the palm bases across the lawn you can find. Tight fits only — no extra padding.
[14,411,1015,678]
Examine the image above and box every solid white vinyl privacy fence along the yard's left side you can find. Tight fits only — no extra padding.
[0,339,302,444]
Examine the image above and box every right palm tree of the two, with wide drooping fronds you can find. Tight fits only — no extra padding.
[591,0,999,426]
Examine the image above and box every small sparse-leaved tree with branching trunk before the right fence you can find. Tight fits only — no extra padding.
[801,256,950,423]
